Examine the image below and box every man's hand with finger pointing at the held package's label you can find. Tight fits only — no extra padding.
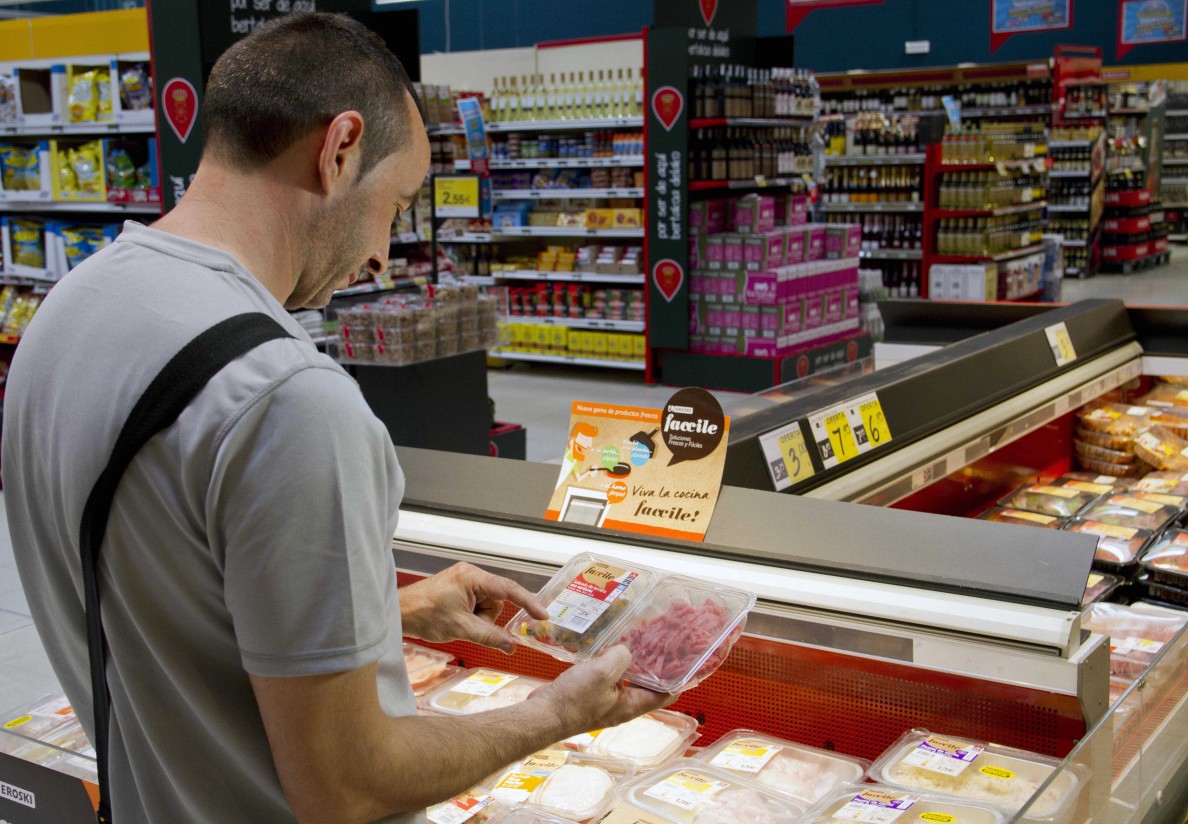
[400,564,549,655]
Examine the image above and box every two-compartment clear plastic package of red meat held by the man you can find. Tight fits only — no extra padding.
[507,553,756,692]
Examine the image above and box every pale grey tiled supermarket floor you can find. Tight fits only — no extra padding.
[0,247,1188,712]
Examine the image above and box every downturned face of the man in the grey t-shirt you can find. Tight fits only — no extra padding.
[285,97,430,309]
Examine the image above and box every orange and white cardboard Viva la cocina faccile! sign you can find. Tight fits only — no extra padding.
[544,388,729,541]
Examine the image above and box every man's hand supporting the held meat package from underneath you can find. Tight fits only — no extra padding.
[529,645,680,737]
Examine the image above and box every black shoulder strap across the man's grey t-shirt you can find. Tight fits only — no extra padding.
[78,312,291,824]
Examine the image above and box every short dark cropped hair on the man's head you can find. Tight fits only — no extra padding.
[204,12,425,177]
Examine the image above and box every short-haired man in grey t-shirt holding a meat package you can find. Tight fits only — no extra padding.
[2,14,670,824]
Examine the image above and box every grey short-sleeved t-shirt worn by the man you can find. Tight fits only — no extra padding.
[2,223,424,824]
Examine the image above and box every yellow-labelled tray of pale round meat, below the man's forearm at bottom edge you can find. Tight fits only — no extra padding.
[484,748,634,822]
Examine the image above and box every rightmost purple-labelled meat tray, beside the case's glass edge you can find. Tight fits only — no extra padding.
[868,729,1083,822]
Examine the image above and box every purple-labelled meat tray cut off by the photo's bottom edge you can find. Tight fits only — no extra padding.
[802,784,1004,824]
